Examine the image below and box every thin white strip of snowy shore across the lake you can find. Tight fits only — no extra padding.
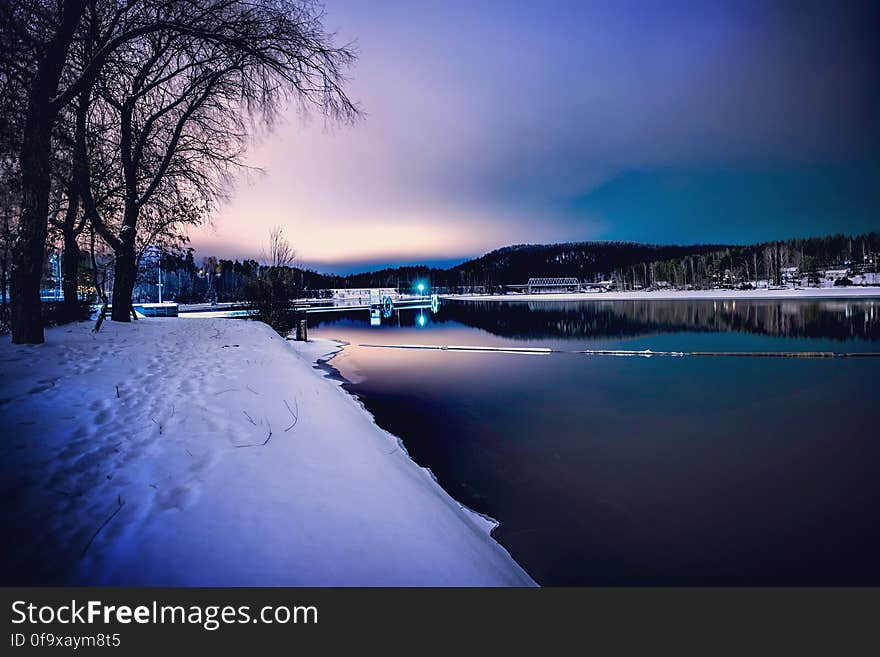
[442,287,880,301]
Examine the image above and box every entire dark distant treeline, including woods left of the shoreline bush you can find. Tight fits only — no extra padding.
[146,232,880,301]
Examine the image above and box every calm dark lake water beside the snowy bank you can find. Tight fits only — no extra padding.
[312,300,880,585]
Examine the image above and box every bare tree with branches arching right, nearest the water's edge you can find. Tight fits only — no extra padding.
[81,3,357,321]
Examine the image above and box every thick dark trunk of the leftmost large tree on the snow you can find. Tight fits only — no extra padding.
[10,0,85,344]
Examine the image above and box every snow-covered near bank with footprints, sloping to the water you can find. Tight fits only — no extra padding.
[0,318,534,586]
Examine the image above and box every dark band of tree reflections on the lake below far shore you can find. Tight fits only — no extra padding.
[438,300,880,340]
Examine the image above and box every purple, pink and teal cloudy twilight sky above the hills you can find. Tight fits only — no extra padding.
[191,0,880,273]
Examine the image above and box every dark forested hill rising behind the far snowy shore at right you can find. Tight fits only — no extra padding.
[306,233,880,289]
